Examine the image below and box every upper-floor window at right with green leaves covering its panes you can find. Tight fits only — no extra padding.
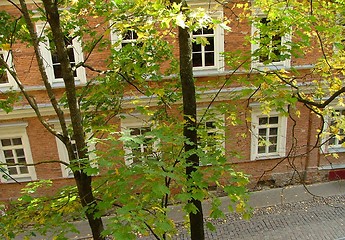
[252,16,291,68]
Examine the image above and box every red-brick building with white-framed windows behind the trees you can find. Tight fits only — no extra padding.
[0,1,345,200]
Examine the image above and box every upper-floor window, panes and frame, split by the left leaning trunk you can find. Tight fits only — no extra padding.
[36,24,86,86]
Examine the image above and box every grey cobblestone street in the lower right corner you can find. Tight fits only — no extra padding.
[141,195,345,240]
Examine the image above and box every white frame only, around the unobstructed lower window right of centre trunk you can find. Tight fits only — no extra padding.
[250,107,287,160]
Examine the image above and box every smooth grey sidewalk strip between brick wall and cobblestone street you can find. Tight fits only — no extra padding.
[15,181,345,240]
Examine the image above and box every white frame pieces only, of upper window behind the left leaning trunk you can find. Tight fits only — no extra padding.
[36,23,86,87]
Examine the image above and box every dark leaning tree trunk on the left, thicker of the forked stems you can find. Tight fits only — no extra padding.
[43,0,104,240]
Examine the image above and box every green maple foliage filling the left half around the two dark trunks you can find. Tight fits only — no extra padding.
[0,0,248,239]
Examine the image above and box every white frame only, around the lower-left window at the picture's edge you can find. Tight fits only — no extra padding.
[0,123,37,183]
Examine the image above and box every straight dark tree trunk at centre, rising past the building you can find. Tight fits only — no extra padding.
[178,6,205,240]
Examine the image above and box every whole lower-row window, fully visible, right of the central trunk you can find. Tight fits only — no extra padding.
[251,111,287,160]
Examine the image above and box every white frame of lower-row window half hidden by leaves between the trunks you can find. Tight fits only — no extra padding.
[121,115,158,166]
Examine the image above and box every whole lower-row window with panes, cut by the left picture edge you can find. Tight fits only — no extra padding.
[0,124,36,182]
